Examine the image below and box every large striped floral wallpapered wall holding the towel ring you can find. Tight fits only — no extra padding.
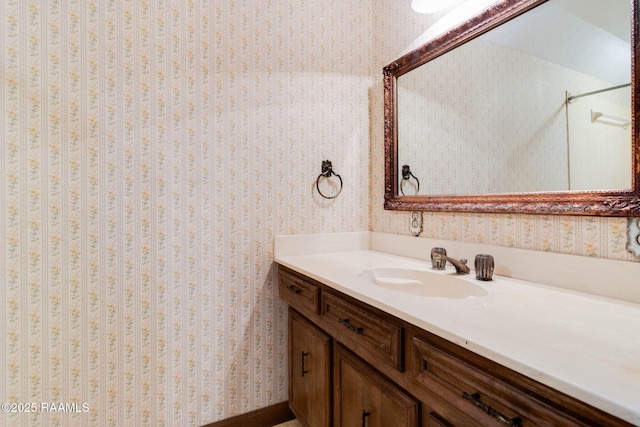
[0,0,372,426]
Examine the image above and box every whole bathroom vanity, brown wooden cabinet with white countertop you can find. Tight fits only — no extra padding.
[276,234,640,427]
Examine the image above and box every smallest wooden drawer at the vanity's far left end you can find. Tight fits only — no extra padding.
[278,267,320,314]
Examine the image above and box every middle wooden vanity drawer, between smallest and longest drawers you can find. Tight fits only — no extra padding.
[321,292,404,371]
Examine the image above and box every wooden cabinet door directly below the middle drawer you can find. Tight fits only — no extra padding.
[334,345,418,427]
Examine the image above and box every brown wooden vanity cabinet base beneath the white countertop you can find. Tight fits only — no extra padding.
[278,266,631,427]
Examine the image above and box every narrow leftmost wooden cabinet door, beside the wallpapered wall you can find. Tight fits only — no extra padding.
[289,309,331,427]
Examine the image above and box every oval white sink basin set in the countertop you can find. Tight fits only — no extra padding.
[362,268,489,298]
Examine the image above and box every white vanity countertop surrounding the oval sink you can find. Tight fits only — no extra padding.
[275,232,640,425]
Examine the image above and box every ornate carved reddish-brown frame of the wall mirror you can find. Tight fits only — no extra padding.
[383,0,640,217]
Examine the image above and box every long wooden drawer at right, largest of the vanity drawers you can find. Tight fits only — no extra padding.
[412,336,624,427]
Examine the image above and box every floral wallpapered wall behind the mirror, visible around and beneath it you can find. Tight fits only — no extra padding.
[370,0,636,262]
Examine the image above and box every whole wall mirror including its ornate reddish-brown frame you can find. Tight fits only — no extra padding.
[384,0,640,216]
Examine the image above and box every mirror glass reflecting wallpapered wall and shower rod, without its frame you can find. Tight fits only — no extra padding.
[397,0,632,195]
